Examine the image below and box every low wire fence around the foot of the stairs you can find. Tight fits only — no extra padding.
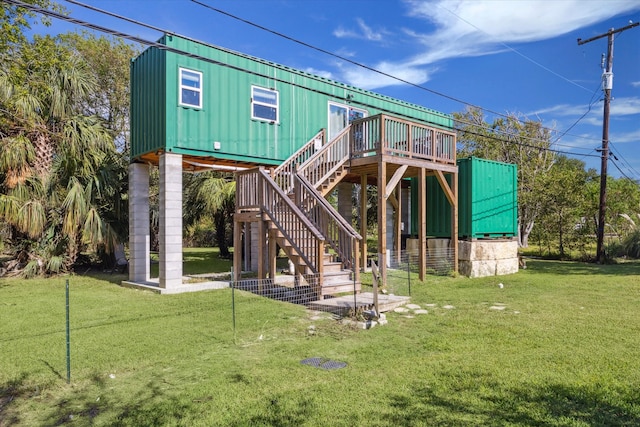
[230,249,453,342]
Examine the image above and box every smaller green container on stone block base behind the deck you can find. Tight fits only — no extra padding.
[420,157,518,239]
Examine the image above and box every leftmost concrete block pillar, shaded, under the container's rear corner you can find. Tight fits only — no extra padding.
[129,163,151,282]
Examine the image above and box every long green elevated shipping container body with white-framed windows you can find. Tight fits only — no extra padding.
[131,35,453,165]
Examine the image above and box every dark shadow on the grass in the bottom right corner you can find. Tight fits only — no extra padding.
[383,384,640,427]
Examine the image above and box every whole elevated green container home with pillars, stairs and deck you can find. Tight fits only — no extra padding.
[130,35,457,297]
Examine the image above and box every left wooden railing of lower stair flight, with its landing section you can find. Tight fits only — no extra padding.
[236,168,325,273]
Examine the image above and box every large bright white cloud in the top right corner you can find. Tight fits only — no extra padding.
[406,0,640,63]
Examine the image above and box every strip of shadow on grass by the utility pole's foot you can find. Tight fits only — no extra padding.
[526,259,640,276]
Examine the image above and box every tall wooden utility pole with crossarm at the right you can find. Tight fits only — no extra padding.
[578,22,639,263]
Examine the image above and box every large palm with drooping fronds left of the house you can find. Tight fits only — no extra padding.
[0,37,126,275]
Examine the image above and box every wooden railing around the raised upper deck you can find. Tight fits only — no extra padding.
[350,114,456,165]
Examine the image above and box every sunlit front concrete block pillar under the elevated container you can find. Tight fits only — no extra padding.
[158,153,182,289]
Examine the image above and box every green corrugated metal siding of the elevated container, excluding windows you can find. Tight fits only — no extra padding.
[127,35,453,164]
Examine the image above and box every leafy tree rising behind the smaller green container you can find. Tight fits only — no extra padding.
[454,108,554,247]
